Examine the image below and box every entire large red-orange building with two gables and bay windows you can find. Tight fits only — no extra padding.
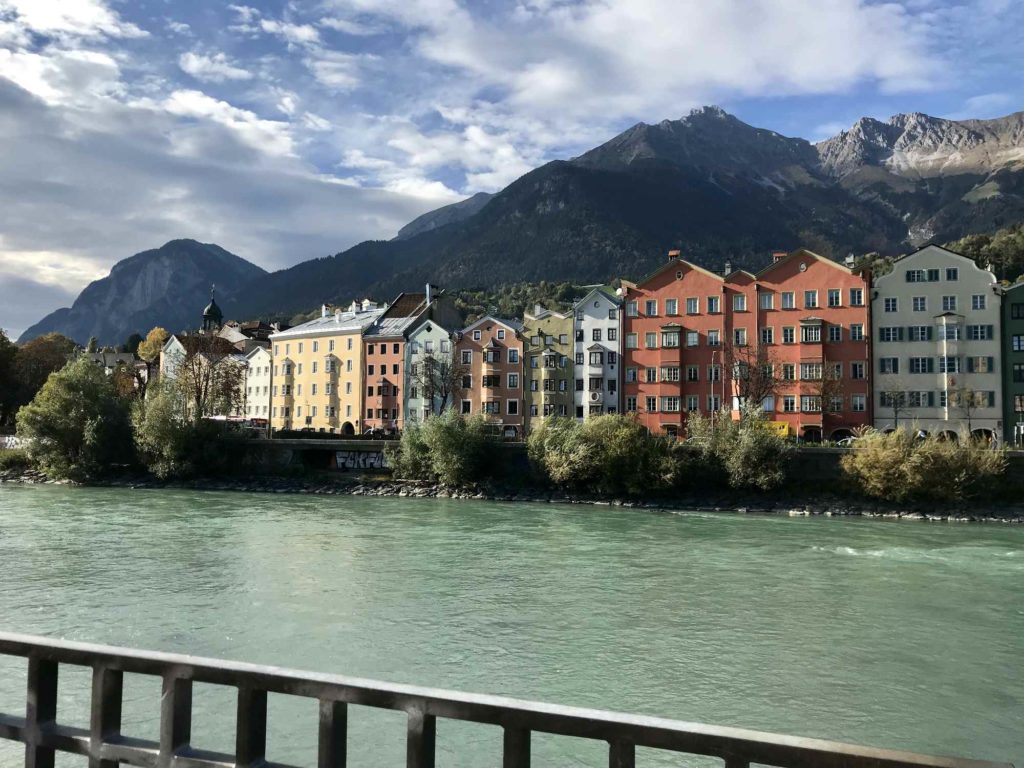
[623,250,871,440]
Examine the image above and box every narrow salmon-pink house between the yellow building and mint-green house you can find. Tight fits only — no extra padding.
[362,285,460,431]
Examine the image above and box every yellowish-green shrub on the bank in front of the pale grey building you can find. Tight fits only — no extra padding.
[842,427,1007,502]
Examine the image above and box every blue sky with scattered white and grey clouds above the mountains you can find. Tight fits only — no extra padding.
[0,0,1024,336]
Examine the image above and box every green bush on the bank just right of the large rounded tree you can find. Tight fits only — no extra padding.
[132,386,234,477]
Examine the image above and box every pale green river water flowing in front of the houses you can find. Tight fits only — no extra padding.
[0,485,1024,768]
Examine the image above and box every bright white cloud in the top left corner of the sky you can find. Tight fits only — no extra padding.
[0,0,148,38]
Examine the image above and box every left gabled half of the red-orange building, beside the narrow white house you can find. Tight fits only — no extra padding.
[621,251,727,436]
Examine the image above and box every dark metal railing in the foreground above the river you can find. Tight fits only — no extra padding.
[0,633,1012,768]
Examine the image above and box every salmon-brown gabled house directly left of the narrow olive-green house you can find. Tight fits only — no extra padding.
[456,315,523,437]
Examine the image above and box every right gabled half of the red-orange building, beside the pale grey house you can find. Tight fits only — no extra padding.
[720,249,871,442]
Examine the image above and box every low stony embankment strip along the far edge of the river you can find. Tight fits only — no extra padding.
[0,470,1024,523]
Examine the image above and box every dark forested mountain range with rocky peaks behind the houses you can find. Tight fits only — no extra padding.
[23,106,1024,341]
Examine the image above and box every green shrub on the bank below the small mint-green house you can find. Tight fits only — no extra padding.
[388,410,498,486]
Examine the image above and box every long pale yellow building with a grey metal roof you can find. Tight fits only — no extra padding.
[270,300,387,434]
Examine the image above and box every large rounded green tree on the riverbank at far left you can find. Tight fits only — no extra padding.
[17,357,133,480]
